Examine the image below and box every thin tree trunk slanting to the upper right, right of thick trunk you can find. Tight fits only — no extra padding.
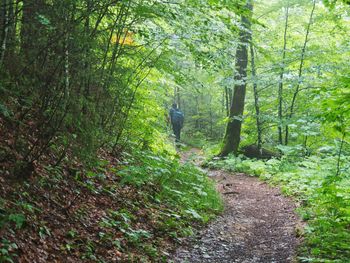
[284,0,316,145]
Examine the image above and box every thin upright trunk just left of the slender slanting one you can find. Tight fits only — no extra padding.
[278,2,289,144]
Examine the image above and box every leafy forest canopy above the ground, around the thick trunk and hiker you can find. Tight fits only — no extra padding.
[1,1,349,163]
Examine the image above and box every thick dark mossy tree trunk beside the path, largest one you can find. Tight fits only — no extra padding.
[220,0,253,156]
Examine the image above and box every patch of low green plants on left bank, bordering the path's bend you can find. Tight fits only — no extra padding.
[118,152,222,223]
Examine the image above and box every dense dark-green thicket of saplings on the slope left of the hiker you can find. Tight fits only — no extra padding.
[0,0,186,171]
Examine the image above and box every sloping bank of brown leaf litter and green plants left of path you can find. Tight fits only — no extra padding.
[0,152,222,262]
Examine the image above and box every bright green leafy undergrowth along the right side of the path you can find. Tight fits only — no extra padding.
[207,155,350,263]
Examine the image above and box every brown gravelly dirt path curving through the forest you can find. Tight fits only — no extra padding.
[173,149,301,263]
